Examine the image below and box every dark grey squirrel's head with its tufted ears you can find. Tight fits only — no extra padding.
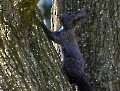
[59,9,87,29]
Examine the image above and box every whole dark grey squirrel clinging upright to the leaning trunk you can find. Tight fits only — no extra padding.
[41,9,93,91]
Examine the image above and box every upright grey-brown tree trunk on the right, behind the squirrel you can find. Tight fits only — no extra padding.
[53,0,120,91]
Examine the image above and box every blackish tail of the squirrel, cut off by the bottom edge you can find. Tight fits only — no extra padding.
[76,77,93,91]
